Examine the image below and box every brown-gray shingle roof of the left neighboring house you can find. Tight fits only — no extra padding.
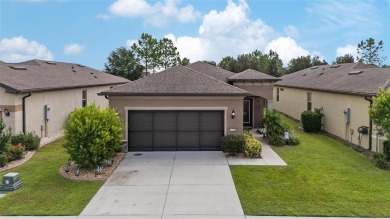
[0,60,128,93]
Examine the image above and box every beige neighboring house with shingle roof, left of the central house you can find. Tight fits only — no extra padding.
[0,60,128,137]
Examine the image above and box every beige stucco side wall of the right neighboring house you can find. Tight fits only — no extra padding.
[273,86,381,150]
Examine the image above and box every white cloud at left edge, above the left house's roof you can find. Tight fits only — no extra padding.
[0,36,53,62]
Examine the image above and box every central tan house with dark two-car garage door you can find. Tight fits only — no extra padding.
[100,62,279,151]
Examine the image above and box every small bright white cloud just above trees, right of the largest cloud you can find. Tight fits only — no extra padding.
[264,37,310,65]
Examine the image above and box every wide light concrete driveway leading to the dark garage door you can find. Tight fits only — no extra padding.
[80,151,245,219]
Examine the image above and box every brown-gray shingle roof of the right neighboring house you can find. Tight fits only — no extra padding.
[275,63,390,96]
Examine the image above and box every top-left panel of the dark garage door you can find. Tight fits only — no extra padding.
[129,111,153,131]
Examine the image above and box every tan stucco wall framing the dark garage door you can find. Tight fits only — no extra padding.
[109,96,244,139]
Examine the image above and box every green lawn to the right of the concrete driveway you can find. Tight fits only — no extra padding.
[230,119,390,217]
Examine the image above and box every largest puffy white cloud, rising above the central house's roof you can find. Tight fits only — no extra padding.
[165,0,276,62]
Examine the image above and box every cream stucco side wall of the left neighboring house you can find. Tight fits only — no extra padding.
[0,86,110,137]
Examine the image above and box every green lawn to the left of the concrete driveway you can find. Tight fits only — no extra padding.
[0,139,104,215]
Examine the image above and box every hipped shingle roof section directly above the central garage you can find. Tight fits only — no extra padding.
[100,66,249,96]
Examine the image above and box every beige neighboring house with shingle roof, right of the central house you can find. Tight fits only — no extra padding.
[273,63,390,151]
